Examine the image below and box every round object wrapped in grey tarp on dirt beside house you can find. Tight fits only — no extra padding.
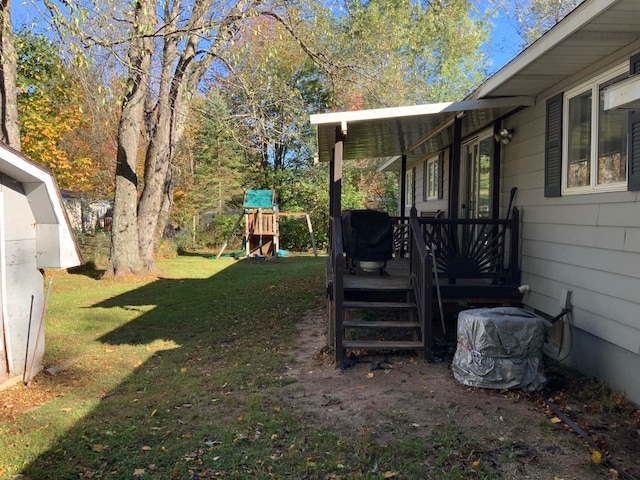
[452,307,547,392]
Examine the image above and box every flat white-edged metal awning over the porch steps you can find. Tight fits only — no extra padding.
[311,96,534,169]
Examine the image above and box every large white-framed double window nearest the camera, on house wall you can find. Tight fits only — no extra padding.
[562,66,629,194]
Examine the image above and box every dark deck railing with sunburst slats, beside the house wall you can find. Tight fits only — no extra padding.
[394,208,520,285]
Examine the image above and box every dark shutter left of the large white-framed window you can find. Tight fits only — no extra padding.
[544,93,563,197]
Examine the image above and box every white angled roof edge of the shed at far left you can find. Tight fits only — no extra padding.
[0,143,82,268]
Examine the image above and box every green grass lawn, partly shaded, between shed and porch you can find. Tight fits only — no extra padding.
[0,255,500,480]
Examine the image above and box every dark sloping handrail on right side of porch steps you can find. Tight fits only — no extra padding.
[407,217,433,360]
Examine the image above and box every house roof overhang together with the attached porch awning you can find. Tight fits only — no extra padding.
[311,0,640,169]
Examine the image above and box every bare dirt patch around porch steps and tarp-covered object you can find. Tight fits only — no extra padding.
[288,311,640,479]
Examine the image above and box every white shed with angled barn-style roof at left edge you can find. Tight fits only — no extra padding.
[0,143,82,388]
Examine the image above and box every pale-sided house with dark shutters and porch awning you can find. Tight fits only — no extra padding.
[311,0,640,404]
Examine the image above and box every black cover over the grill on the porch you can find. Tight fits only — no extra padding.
[342,210,393,262]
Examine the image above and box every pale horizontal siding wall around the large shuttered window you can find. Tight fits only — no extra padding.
[501,51,640,404]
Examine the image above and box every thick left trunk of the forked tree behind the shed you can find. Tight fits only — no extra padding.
[105,0,155,276]
